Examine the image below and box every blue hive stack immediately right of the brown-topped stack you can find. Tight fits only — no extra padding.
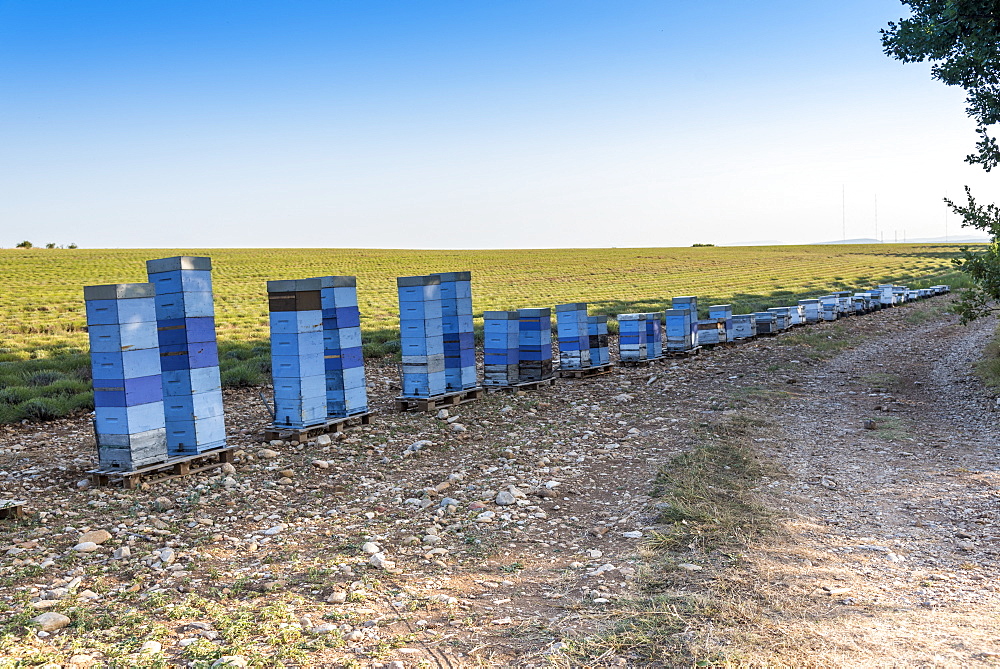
[316,276,368,419]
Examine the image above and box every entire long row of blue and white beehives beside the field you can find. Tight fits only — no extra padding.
[84,256,948,469]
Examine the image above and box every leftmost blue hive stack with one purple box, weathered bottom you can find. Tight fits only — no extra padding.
[83,283,168,471]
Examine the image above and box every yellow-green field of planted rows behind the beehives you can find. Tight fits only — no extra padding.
[0,244,972,422]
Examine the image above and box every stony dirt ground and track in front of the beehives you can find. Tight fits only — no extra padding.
[0,298,1000,667]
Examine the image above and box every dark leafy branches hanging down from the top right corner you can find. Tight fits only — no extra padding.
[881,0,1000,172]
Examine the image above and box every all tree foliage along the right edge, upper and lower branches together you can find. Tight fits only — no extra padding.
[881,0,1000,322]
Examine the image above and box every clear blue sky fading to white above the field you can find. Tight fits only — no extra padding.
[0,0,1000,249]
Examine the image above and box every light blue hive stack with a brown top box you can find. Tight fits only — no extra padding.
[267,279,327,429]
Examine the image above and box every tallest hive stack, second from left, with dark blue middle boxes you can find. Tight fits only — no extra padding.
[146,256,226,456]
